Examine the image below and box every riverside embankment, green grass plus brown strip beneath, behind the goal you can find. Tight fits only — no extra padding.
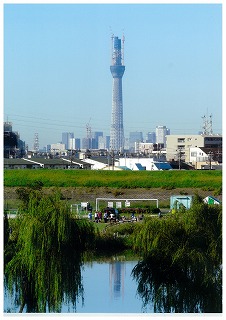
[4,169,222,206]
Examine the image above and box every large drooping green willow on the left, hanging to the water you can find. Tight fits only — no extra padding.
[5,191,94,312]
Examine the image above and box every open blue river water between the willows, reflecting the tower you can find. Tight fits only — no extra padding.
[4,257,150,313]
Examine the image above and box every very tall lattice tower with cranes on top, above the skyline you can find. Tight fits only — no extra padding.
[110,35,125,151]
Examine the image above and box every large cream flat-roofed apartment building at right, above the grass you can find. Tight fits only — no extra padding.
[166,134,222,163]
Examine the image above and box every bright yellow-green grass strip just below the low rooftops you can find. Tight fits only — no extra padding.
[4,169,222,189]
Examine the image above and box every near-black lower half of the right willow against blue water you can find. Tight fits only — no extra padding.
[133,257,222,313]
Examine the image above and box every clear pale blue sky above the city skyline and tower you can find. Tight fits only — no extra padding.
[3,4,222,148]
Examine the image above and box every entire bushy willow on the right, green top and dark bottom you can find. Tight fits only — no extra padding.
[132,197,222,313]
